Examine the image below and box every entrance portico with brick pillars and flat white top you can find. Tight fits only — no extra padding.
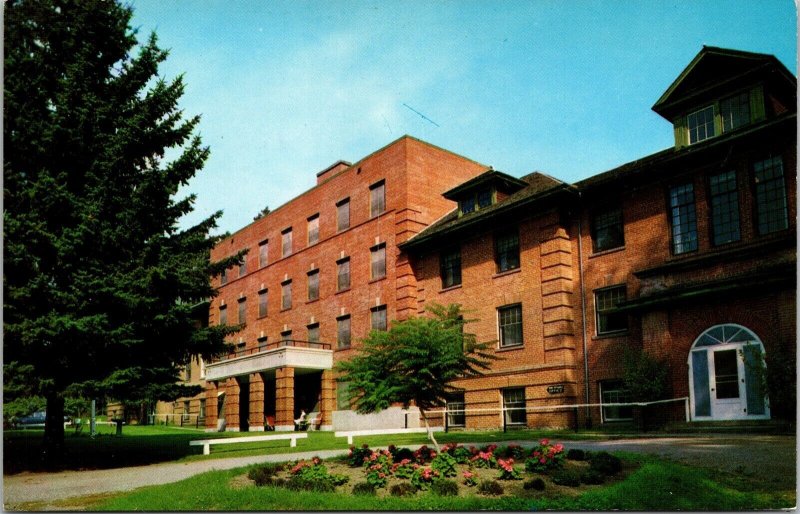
[206,340,334,432]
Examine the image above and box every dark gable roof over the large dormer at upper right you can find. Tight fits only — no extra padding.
[652,45,796,119]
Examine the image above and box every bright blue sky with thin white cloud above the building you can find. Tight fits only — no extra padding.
[131,0,797,232]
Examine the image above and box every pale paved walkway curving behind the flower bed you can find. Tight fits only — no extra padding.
[3,434,797,510]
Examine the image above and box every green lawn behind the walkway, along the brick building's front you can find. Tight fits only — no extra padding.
[3,425,606,473]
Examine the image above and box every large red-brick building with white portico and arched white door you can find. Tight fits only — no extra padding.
[166,47,797,430]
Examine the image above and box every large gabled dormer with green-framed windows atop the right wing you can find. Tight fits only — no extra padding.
[653,46,797,148]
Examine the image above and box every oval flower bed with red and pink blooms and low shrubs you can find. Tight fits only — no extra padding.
[244,439,623,496]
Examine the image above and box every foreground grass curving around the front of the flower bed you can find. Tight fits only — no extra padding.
[91,455,794,511]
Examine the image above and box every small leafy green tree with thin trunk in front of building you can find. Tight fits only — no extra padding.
[336,304,496,451]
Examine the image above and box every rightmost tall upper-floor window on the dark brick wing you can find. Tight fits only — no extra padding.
[753,156,789,235]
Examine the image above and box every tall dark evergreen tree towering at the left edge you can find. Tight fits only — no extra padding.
[3,0,241,459]
